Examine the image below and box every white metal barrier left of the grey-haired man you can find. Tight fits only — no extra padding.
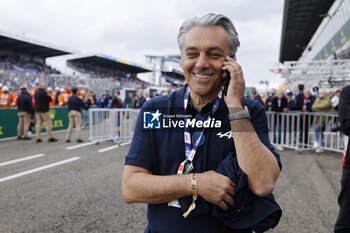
[89,108,139,143]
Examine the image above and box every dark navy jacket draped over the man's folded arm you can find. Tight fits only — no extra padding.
[179,152,282,232]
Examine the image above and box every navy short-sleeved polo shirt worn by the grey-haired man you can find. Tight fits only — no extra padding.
[125,85,280,233]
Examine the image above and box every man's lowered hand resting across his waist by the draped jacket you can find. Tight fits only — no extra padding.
[197,171,236,210]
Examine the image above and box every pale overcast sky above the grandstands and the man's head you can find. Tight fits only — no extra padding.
[0,0,284,87]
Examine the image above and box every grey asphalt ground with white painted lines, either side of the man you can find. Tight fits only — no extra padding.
[0,129,342,233]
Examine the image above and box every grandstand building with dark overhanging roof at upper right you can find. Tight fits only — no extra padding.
[279,0,350,90]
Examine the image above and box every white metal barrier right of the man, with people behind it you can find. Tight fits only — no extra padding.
[266,112,343,153]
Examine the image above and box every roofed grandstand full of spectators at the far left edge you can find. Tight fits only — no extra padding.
[0,31,75,93]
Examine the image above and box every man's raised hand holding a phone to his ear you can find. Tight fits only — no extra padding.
[222,56,245,108]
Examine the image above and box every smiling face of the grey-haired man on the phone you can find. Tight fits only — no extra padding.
[181,26,230,97]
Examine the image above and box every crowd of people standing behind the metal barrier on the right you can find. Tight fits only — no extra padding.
[251,84,340,153]
